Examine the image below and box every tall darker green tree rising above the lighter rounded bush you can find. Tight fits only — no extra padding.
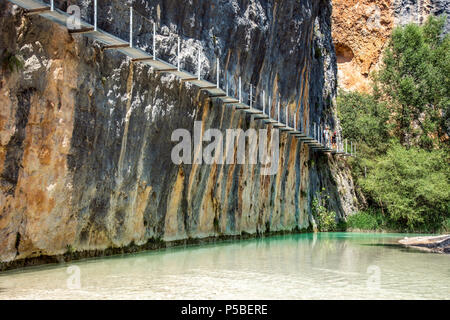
[374,17,450,150]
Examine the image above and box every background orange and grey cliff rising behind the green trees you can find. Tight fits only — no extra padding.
[333,0,450,92]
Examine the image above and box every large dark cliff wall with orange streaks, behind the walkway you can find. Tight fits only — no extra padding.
[0,0,356,266]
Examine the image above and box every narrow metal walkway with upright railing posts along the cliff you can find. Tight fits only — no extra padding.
[9,0,356,156]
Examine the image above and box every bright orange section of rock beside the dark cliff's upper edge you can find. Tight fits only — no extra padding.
[333,0,394,92]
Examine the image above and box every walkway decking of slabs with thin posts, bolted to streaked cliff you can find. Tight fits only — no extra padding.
[9,0,353,156]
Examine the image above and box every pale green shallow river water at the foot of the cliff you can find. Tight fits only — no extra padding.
[0,233,450,299]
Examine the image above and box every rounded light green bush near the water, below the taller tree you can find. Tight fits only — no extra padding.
[359,144,450,231]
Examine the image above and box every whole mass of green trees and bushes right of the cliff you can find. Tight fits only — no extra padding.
[338,18,450,232]
